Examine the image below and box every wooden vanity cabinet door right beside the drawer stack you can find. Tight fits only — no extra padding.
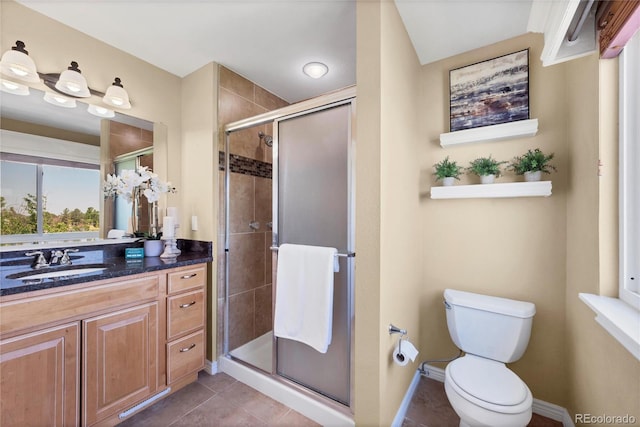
[83,302,159,425]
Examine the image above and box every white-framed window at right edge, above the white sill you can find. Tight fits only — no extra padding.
[619,32,640,310]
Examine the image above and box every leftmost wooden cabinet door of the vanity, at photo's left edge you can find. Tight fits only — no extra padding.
[0,323,80,427]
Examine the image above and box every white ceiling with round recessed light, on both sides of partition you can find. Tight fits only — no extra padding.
[12,0,532,102]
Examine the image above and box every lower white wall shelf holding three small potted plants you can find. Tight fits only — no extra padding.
[431,181,551,199]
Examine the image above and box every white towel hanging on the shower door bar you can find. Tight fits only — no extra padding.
[273,244,338,353]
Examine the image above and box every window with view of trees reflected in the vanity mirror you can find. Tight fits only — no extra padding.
[0,129,102,245]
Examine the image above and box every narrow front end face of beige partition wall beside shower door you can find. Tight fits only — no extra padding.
[353,2,382,426]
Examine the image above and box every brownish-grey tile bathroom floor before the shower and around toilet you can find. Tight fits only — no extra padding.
[120,371,562,427]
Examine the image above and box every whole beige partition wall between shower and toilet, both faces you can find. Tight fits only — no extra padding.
[355,2,424,426]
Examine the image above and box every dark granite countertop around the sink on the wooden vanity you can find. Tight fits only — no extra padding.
[0,239,213,296]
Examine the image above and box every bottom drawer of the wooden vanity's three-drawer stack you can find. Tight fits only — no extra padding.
[167,331,205,384]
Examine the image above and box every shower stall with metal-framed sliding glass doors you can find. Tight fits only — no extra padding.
[218,88,355,422]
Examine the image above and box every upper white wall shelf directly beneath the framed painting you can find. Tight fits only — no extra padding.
[440,119,538,148]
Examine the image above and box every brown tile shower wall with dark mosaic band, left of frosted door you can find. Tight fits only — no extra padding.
[217,66,288,355]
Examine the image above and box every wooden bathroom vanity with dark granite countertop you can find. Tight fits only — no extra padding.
[0,241,212,426]
